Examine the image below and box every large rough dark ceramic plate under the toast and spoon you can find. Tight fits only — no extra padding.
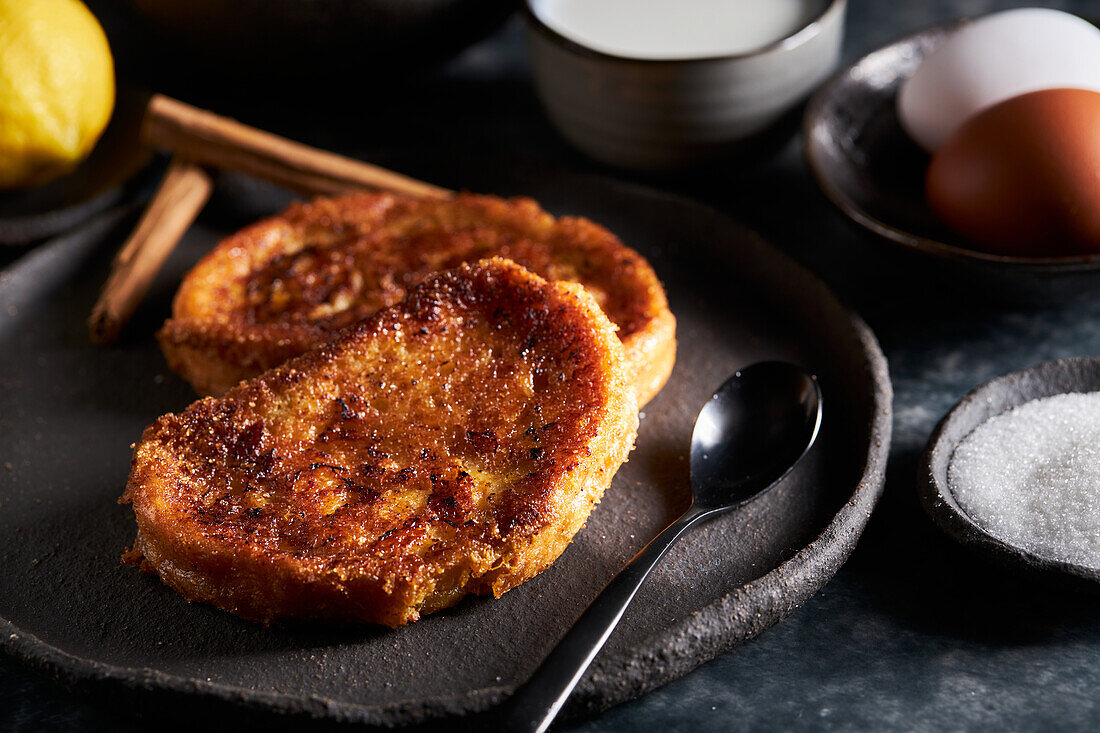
[0,167,891,724]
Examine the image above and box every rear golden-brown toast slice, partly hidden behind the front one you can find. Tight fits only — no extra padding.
[158,194,675,405]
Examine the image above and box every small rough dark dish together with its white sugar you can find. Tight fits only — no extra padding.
[917,357,1100,581]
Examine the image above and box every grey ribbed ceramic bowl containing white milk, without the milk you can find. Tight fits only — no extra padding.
[526,0,847,171]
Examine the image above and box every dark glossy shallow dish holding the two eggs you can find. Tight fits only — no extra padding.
[804,20,1100,303]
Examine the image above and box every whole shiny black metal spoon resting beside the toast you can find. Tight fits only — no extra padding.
[503,361,822,733]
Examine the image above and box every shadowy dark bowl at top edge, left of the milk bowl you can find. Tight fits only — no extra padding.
[113,0,518,80]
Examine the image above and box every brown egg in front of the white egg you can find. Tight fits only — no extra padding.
[925,89,1100,256]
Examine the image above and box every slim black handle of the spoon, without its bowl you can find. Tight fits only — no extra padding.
[502,507,705,733]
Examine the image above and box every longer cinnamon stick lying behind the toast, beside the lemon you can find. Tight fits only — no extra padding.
[142,95,452,198]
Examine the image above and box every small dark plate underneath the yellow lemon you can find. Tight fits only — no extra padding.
[0,89,152,244]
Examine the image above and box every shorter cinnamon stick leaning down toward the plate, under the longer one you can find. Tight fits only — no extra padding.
[88,156,213,343]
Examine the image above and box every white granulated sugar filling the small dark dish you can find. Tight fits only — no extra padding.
[947,392,1100,569]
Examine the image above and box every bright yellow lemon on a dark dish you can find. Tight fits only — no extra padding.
[0,0,114,188]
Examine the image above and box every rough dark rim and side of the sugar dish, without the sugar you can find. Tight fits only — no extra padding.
[917,357,1100,581]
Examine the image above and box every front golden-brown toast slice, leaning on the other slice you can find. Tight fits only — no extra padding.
[121,259,638,626]
